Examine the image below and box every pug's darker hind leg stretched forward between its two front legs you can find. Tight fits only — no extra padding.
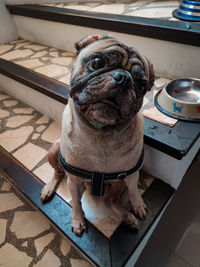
[104,181,139,229]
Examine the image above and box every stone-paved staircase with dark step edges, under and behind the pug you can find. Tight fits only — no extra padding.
[0,3,200,266]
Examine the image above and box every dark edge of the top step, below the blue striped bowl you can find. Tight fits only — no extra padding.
[6,5,200,47]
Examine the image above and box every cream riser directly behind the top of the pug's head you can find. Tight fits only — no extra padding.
[13,15,200,78]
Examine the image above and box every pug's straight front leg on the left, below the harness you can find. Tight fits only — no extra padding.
[68,174,87,237]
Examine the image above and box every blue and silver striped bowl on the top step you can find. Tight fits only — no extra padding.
[172,0,200,21]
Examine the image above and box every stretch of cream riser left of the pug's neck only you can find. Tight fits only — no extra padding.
[0,74,65,123]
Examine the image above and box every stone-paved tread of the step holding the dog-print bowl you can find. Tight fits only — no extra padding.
[0,39,177,127]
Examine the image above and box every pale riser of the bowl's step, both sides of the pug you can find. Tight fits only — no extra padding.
[0,74,200,189]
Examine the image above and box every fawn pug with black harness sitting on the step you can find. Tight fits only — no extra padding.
[41,35,154,236]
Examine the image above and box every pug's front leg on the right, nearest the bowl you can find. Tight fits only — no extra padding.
[124,171,146,219]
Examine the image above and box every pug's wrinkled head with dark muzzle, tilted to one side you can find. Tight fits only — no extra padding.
[70,36,154,129]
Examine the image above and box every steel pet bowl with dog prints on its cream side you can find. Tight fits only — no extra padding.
[154,78,200,122]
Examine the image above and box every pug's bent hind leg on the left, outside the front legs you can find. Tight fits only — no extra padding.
[40,139,65,201]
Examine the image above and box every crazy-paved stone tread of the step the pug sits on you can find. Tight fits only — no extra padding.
[0,93,154,238]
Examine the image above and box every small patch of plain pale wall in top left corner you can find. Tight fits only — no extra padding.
[0,0,19,44]
